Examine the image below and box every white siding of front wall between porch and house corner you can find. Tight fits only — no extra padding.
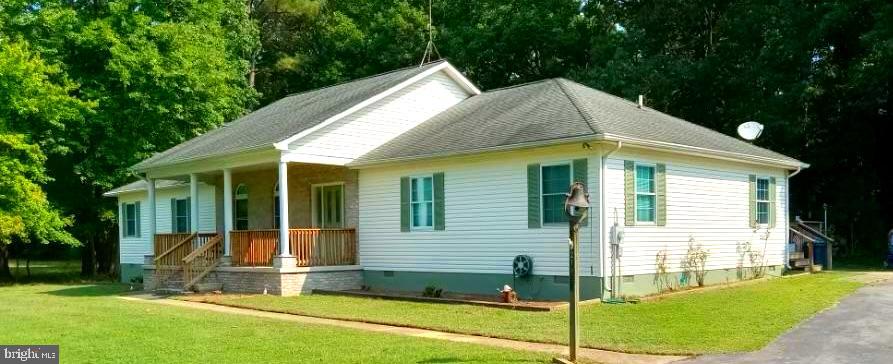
[357,145,600,276]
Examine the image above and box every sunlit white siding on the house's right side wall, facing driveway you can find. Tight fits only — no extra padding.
[605,146,787,275]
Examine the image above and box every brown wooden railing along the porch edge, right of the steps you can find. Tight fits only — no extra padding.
[230,229,357,267]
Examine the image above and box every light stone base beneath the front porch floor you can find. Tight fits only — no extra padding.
[143,266,363,296]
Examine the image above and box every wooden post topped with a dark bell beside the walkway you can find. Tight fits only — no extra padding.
[564,182,589,363]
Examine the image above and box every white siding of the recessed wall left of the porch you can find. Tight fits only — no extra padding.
[118,183,217,264]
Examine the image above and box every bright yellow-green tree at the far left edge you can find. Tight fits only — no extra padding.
[0,40,83,278]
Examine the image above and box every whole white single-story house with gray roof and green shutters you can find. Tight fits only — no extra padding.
[108,61,807,299]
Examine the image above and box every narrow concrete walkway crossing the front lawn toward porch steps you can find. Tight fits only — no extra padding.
[121,294,685,364]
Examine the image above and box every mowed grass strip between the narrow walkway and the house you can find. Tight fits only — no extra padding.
[185,272,862,354]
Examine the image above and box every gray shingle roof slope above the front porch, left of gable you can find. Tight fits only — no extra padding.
[133,61,443,169]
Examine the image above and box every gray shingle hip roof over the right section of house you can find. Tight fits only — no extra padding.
[353,78,802,165]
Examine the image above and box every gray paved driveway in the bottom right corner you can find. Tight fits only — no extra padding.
[684,272,893,364]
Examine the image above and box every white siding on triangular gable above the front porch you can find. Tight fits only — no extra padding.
[288,71,469,165]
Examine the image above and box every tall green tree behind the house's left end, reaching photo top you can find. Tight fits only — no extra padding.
[0,0,256,276]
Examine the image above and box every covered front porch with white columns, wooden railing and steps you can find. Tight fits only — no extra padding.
[144,158,361,294]
